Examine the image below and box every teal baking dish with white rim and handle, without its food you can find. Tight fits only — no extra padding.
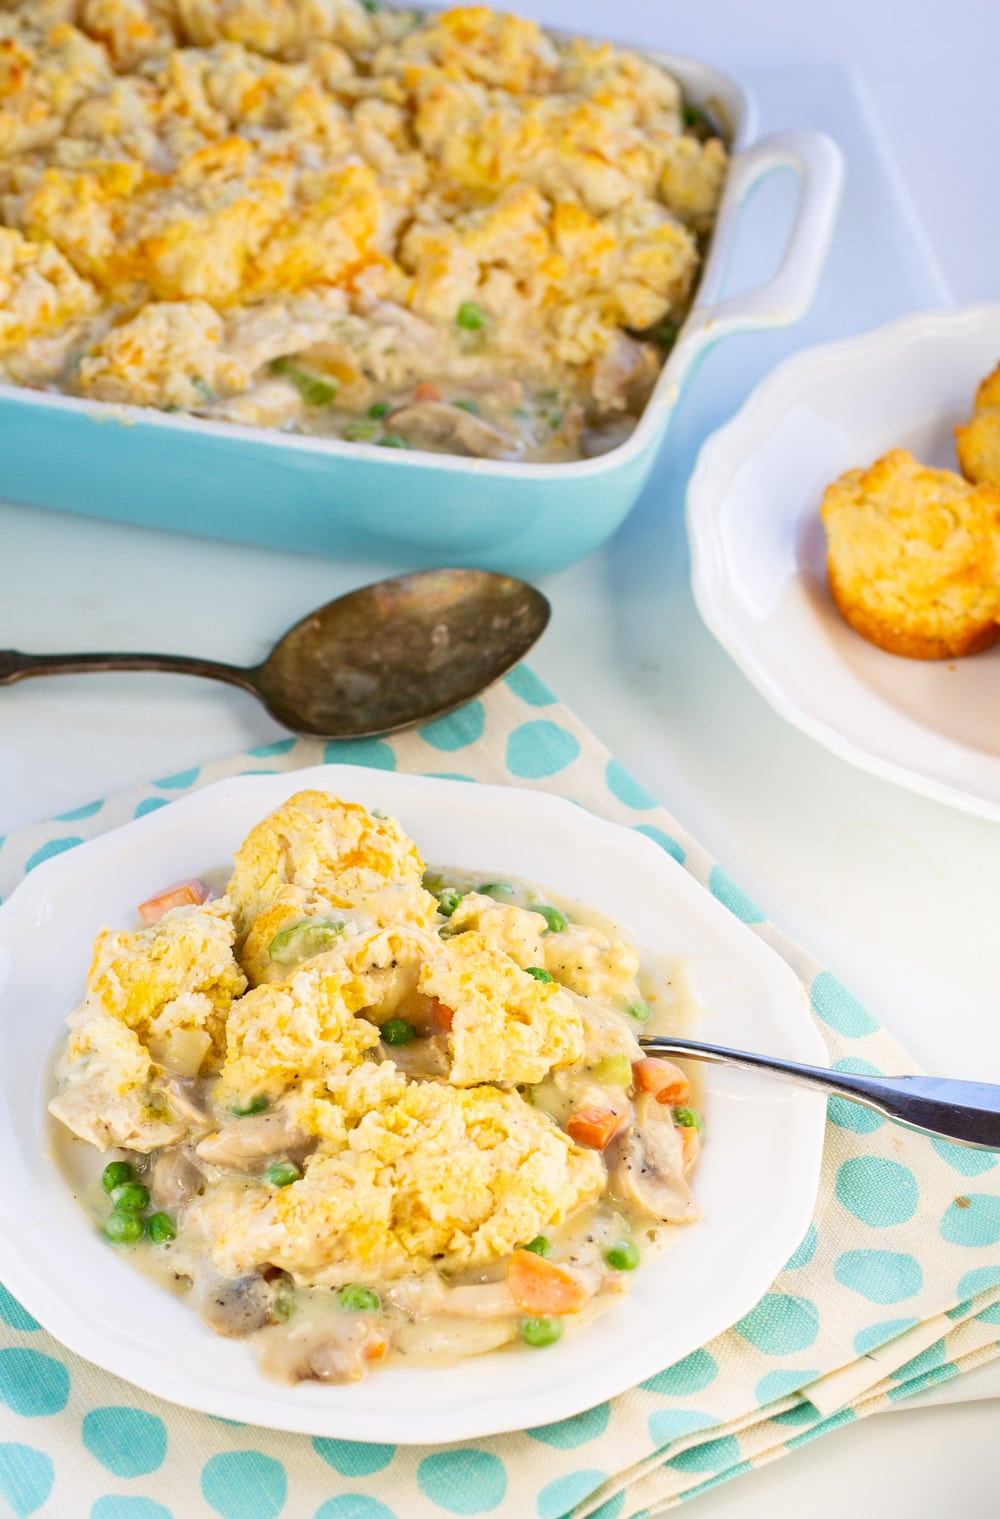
[0,53,842,577]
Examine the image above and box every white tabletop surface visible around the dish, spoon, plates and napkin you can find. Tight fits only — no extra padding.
[0,0,1000,1519]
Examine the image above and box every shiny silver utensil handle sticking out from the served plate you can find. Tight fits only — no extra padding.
[638,1034,1000,1150]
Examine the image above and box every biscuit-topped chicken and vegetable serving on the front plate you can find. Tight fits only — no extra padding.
[50,791,702,1382]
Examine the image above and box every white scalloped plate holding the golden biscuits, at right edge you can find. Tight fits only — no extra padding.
[687,305,1000,819]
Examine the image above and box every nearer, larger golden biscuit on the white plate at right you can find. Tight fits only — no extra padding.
[821,448,1000,659]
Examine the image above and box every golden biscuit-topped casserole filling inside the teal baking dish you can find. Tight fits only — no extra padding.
[0,0,726,462]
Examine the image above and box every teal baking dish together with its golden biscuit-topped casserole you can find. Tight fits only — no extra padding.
[0,0,837,573]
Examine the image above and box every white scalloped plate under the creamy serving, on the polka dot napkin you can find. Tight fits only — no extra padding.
[0,766,825,1443]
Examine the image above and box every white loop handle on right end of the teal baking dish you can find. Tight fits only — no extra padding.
[678,131,843,368]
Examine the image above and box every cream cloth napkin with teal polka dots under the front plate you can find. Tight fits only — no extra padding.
[0,667,1000,1519]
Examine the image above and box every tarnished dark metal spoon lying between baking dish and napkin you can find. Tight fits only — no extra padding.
[0,570,552,738]
